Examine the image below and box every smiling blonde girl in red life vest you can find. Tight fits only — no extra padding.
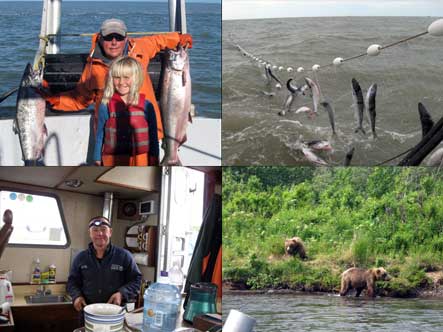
[94,57,159,166]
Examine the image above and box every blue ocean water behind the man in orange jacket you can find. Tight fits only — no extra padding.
[0,1,221,118]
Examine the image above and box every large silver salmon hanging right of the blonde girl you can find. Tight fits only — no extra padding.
[160,46,191,166]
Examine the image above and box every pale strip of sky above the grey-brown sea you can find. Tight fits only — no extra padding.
[222,0,443,20]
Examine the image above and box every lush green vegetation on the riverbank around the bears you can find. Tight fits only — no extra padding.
[223,167,443,296]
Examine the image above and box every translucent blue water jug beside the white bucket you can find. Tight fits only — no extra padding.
[143,282,180,332]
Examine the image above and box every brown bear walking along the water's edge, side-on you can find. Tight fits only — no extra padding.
[340,267,391,297]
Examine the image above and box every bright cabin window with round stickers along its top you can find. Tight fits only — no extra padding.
[0,190,70,248]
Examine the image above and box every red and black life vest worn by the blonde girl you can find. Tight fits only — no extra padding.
[103,93,149,156]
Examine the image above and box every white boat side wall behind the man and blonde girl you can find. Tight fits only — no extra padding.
[0,113,221,166]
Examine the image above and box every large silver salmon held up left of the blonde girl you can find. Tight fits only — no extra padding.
[14,63,48,166]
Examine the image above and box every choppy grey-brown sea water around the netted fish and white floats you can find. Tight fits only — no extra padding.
[222,17,443,166]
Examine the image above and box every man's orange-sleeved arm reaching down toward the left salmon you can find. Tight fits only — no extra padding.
[45,63,99,111]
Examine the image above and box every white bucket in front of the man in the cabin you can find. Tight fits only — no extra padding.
[83,303,125,332]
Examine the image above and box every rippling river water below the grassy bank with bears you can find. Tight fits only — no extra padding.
[222,293,443,332]
